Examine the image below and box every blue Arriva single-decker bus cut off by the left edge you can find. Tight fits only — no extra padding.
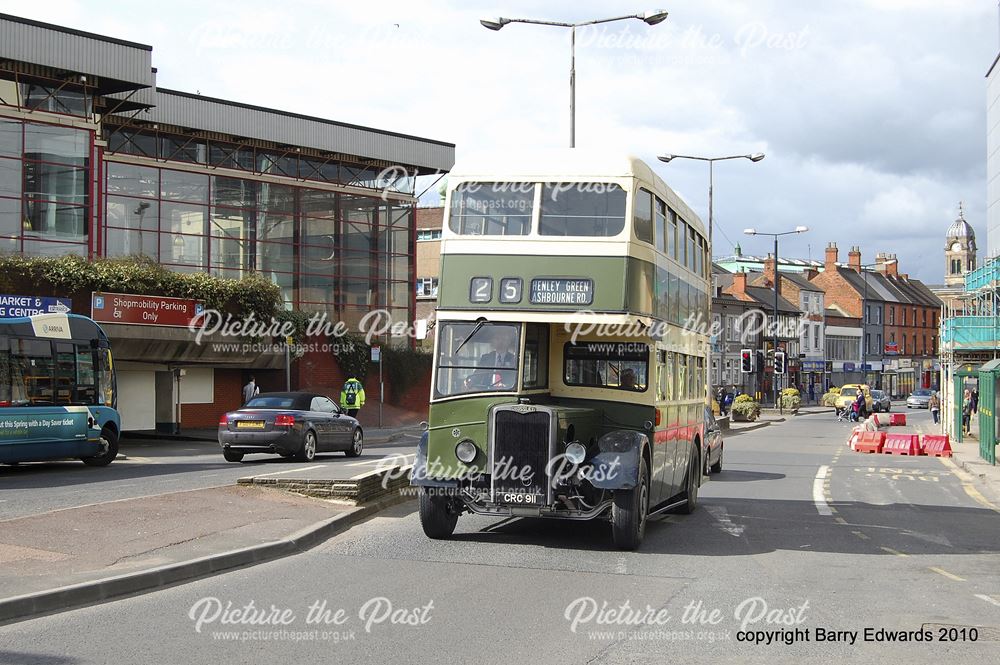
[0,314,121,466]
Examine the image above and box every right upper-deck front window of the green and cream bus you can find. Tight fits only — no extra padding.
[538,182,625,238]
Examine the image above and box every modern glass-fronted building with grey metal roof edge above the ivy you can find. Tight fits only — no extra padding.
[0,15,455,428]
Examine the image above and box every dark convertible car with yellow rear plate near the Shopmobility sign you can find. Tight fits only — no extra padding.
[219,392,364,462]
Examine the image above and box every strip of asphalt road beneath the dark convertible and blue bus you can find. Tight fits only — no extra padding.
[0,434,419,522]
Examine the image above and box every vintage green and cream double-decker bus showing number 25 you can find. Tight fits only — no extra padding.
[411,150,711,549]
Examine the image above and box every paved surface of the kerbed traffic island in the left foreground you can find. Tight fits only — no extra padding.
[0,486,356,601]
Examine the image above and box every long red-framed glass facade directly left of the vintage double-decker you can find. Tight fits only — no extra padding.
[103,161,415,327]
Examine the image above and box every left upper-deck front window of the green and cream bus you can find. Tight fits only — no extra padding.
[448,182,535,236]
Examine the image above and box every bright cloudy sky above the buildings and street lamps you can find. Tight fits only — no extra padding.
[0,0,1000,283]
